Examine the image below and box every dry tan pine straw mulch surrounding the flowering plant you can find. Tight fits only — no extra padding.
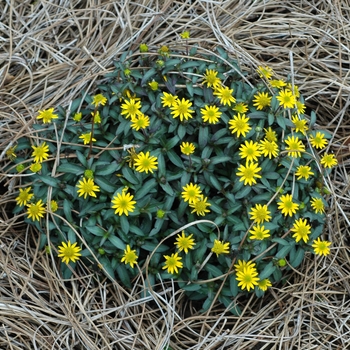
[0,0,350,350]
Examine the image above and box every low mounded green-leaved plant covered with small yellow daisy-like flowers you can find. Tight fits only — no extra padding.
[7,35,337,313]
